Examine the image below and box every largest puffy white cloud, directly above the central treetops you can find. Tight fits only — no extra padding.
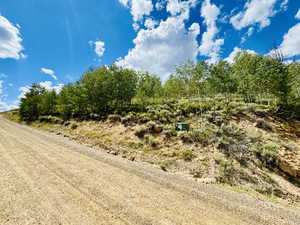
[117,16,200,80]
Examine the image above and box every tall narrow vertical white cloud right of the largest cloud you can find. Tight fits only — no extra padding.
[199,0,224,63]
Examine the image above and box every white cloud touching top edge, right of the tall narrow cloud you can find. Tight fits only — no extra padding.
[230,0,278,30]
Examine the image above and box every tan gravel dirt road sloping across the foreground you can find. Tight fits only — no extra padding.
[0,116,300,225]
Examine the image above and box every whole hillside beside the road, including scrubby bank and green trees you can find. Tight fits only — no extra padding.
[9,51,300,205]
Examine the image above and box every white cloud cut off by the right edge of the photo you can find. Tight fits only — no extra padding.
[279,23,300,57]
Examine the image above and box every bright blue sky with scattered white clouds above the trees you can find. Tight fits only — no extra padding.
[0,0,300,111]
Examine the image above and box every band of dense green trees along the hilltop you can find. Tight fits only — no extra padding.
[20,52,300,121]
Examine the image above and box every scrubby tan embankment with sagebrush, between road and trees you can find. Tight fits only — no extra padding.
[7,99,300,206]
